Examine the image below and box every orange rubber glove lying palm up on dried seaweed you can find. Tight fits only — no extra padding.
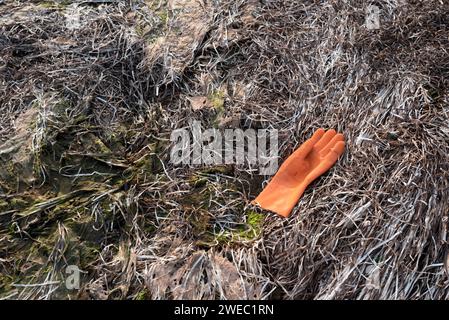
[251,128,345,217]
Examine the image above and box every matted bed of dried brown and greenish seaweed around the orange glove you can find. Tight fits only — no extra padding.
[0,0,449,299]
